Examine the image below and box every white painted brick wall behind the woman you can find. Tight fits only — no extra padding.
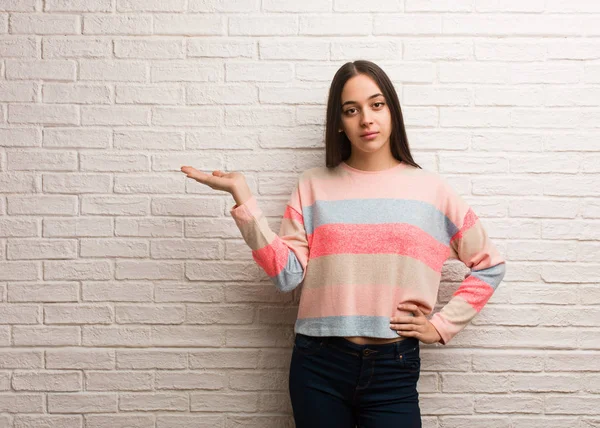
[0,0,600,428]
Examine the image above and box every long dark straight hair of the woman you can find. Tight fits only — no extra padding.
[325,60,422,169]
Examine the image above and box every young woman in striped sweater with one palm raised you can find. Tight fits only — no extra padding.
[181,61,505,428]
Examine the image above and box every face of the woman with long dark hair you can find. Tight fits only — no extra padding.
[341,74,392,159]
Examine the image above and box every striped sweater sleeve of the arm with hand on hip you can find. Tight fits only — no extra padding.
[430,177,506,345]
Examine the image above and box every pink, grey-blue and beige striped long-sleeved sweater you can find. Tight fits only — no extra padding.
[230,162,505,345]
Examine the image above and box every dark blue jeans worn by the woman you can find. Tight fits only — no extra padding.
[289,334,421,428]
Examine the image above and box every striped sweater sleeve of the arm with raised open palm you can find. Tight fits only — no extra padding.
[230,179,309,292]
